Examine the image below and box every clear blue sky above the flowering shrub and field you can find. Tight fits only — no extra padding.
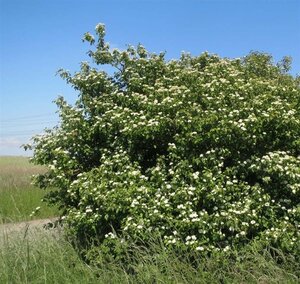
[0,0,300,155]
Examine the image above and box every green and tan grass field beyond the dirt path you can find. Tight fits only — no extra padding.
[0,157,58,223]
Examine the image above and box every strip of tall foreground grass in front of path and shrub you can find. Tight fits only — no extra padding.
[0,226,300,284]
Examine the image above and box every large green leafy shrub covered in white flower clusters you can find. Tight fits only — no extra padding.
[26,25,300,253]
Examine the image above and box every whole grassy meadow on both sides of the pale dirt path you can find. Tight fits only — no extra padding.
[0,157,300,284]
